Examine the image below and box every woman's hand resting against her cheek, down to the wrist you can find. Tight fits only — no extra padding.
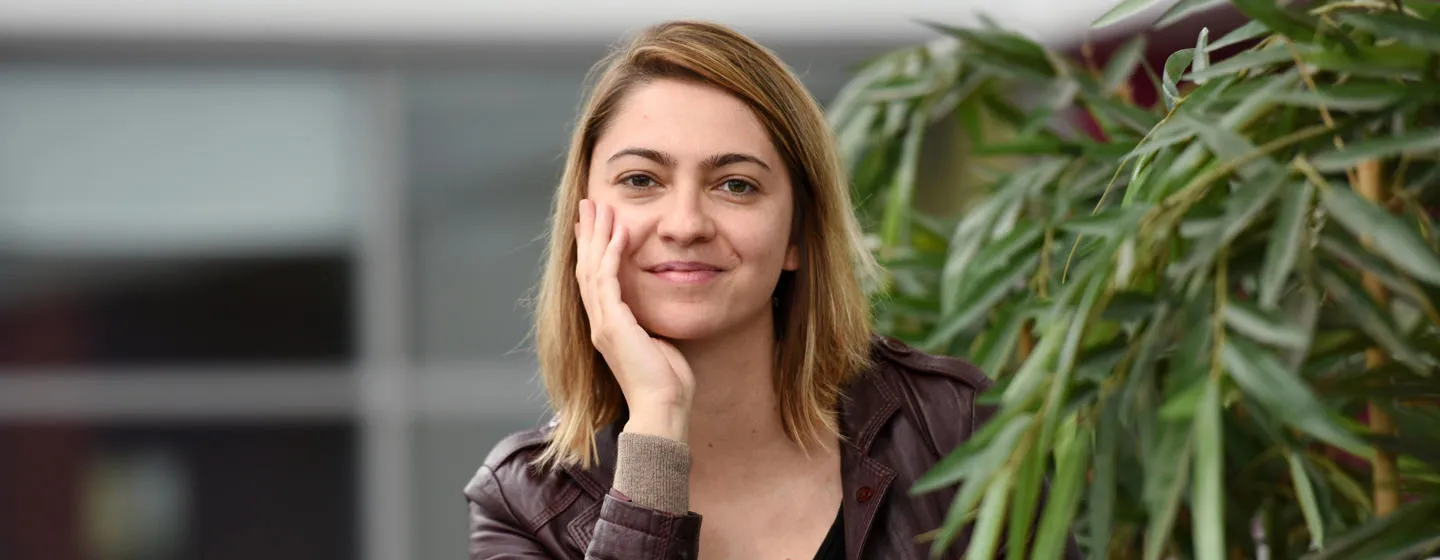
[575,199,696,442]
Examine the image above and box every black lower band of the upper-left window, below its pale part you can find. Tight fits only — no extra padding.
[0,255,354,369]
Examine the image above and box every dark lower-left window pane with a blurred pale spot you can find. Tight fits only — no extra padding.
[0,423,357,560]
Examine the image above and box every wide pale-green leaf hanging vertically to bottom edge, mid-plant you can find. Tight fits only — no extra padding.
[1189,379,1225,560]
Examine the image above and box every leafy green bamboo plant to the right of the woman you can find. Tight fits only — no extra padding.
[831,0,1440,560]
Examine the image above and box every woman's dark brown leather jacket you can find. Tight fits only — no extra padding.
[465,333,1079,560]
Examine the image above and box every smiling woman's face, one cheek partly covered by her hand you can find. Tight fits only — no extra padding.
[588,79,799,340]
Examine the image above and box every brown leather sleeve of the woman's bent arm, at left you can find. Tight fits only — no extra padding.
[465,466,700,560]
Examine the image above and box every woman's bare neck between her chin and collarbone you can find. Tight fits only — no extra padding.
[674,314,789,455]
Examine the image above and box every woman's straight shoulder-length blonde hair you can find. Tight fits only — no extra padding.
[534,22,877,466]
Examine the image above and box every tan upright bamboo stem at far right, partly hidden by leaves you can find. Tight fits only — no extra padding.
[1355,160,1400,517]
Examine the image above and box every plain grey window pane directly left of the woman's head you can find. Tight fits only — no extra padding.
[408,49,603,361]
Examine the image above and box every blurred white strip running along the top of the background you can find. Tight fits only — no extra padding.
[0,0,1152,42]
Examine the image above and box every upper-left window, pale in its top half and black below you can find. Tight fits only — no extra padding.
[0,60,365,367]
